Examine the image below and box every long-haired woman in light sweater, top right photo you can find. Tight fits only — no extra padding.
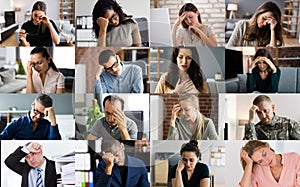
[227,2,283,47]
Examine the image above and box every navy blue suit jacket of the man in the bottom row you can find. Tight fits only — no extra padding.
[95,156,150,187]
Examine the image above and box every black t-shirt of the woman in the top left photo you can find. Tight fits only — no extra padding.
[21,20,59,47]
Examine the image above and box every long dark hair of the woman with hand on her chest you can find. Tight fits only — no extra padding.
[166,47,204,93]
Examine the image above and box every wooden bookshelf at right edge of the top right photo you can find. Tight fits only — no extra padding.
[282,0,300,37]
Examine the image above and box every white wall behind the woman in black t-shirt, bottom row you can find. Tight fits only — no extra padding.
[150,140,225,186]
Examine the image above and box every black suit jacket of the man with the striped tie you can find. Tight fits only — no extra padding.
[5,147,57,187]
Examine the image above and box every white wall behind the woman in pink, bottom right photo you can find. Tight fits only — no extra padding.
[224,141,300,186]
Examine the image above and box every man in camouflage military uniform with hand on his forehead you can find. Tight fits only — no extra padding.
[244,95,300,140]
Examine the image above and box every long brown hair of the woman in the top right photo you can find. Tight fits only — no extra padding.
[244,2,283,46]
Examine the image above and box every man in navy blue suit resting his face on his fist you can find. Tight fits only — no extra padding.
[95,140,150,187]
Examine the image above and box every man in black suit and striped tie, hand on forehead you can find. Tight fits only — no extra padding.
[5,142,57,187]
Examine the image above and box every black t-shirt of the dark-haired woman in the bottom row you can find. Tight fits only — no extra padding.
[171,162,209,187]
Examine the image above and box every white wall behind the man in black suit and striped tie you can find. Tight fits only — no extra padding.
[1,140,75,186]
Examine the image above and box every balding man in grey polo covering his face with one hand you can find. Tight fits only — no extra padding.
[87,95,138,140]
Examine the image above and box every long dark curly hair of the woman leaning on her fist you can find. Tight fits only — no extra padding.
[93,0,135,38]
